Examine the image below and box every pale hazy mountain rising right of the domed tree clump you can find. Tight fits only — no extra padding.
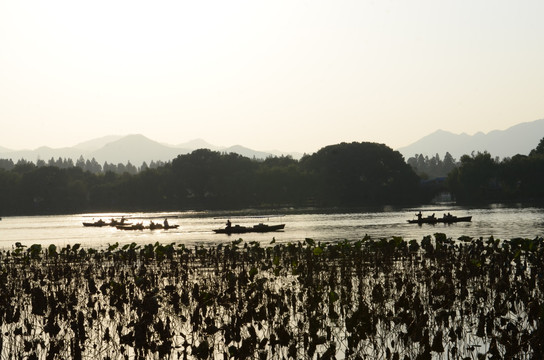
[397,119,544,160]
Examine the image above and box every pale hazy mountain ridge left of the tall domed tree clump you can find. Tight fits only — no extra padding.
[0,135,302,166]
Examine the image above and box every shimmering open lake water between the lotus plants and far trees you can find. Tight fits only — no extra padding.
[0,205,544,249]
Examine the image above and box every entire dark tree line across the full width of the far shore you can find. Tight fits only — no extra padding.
[0,138,544,215]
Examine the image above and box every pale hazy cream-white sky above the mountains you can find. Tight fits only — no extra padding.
[0,0,544,153]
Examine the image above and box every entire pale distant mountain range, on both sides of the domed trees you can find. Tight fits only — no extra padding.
[0,119,544,166]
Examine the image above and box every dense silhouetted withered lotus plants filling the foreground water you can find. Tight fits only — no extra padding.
[0,234,544,360]
